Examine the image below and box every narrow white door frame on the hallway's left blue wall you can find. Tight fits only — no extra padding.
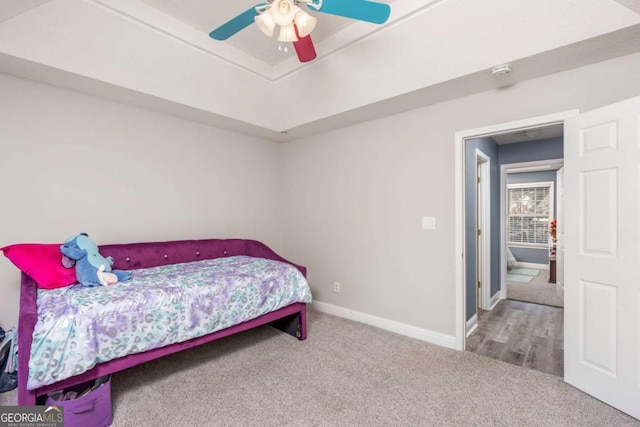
[476,148,491,314]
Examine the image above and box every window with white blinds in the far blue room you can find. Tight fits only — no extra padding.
[507,182,553,247]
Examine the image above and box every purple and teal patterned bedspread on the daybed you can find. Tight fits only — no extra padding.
[27,256,311,390]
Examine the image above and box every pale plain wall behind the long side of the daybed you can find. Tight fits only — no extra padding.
[0,74,282,328]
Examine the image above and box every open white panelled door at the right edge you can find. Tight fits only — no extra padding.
[564,98,640,418]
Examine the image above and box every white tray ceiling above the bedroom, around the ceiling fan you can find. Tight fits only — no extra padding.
[0,0,640,141]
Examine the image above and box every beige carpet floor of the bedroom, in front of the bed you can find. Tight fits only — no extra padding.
[0,312,640,427]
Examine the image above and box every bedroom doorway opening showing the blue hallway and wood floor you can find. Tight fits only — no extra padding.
[465,128,564,377]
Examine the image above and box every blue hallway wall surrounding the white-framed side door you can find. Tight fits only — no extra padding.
[465,137,500,320]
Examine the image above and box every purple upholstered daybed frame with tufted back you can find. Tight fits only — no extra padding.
[18,239,307,405]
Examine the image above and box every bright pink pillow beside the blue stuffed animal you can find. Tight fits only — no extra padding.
[0,243,78,289]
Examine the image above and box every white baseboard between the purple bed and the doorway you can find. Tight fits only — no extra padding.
[311,301,456,349]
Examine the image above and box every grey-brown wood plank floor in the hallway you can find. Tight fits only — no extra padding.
[467,300,564,377]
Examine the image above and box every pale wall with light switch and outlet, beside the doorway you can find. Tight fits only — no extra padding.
[282,54,640,336]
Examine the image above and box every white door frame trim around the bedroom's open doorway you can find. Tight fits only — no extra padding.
[454,110,579,351]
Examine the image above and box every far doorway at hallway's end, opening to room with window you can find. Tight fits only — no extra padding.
[500,159,564,307]
